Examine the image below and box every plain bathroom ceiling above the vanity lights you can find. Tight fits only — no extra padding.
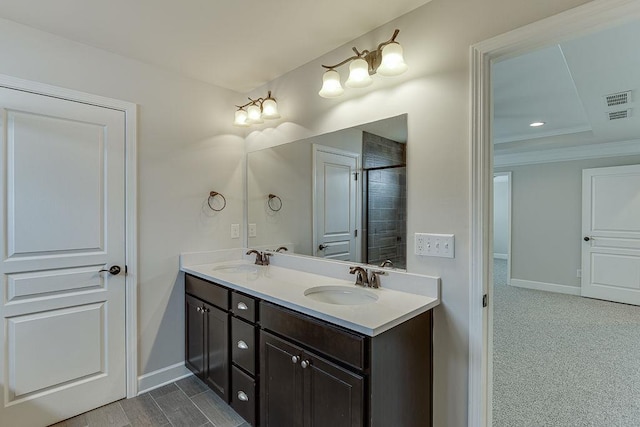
[0,0,430,93]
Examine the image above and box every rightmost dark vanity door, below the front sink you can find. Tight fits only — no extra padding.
[301,353,364,427]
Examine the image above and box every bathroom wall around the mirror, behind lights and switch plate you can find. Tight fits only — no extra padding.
[242,0,585,427]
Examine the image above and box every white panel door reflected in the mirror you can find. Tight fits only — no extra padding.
[314,145,358,262]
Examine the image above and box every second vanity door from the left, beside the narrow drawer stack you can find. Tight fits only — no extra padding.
[204,304,229,403]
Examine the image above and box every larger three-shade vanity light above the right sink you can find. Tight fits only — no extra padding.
[318,30,409,98]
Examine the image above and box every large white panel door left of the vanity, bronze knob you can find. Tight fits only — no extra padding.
[0,88,126,427]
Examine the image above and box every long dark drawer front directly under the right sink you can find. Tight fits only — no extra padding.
[260,302,368,369]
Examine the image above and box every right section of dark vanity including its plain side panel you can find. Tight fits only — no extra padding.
[260,302,432,427]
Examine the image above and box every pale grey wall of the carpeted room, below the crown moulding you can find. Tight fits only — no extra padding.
[496,155,640,288]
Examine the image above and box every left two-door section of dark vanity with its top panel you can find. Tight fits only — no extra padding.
[185,275,230,402]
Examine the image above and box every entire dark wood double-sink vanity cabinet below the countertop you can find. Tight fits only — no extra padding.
[185,274,432,427]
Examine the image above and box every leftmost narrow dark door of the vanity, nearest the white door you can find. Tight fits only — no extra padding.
[185,295,205,378]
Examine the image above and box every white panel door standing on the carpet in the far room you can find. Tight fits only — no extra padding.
[582,165,640,305]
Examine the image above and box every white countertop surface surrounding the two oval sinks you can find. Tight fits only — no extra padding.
[181,260,440,336]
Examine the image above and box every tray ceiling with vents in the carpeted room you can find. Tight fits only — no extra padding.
[492,22,640,155]
